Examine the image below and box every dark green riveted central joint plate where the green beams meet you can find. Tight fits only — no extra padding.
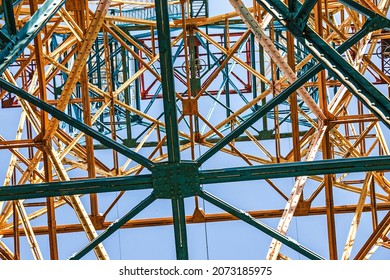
[152,161,200,199]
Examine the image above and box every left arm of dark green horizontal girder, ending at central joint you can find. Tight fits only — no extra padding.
[0,175,153,201]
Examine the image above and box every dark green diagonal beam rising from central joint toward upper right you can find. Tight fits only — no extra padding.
[197,16,375,166]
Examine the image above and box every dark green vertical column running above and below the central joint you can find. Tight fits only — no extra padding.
[155,0,188,259]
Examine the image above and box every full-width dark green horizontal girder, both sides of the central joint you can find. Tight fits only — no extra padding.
[0,156,390,201]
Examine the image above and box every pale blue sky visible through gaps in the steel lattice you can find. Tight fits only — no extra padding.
[0,0,390,259]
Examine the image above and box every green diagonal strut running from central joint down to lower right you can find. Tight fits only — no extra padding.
[200,191,324,260]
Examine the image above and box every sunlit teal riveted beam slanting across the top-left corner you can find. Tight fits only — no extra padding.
[0,0,66,74]
